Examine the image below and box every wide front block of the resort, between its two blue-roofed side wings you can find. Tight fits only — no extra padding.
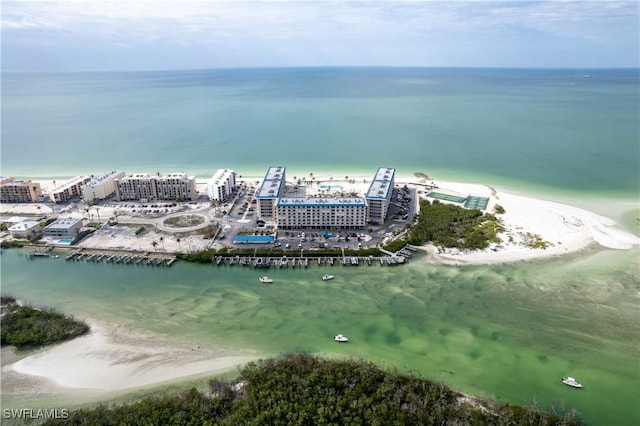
[277,197,367,229]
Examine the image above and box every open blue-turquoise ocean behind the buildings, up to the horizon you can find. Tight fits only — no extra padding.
[1,68,640,197]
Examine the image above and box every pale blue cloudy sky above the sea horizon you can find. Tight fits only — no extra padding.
[1,0,640,71]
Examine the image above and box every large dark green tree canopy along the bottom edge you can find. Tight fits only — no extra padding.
[45,353,578,425]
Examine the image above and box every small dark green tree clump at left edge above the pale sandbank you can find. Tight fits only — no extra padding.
[0,296,89,348]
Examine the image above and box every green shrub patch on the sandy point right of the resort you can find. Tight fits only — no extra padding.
[404,200,503,249]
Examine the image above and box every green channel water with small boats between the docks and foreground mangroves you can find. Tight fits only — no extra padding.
[2,250,640,425]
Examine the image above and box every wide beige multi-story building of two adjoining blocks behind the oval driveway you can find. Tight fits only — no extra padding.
[115,173,198,202]
